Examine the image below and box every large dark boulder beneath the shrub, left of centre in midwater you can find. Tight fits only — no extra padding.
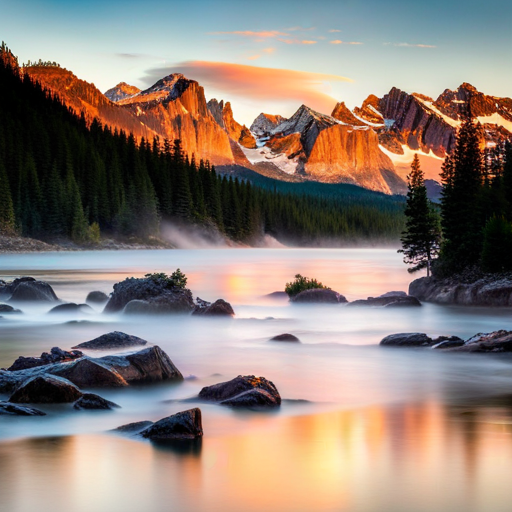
[103,277,194,313]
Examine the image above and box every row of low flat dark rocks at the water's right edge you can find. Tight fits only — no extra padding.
[380,330,512,353]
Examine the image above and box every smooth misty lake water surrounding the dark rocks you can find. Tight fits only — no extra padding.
[0,249,512,512]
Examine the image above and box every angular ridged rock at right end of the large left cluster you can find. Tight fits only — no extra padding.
[100,346,183,384]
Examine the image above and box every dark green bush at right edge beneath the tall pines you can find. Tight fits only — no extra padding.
[482,217,512,272]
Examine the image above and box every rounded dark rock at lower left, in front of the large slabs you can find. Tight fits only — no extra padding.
[9,375,82,404]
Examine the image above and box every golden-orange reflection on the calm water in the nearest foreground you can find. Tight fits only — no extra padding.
[0,402,512,512]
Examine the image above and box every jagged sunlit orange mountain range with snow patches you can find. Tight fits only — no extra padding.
[23,66,512,194]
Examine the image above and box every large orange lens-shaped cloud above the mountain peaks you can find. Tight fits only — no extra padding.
[145,61,353,113]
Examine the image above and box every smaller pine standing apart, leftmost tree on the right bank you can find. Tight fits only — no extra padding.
[398,154,440,276]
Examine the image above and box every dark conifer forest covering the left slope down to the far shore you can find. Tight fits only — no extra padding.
[0,50,404,244]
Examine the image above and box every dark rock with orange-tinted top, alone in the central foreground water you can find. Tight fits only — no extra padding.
[199,375,281,407]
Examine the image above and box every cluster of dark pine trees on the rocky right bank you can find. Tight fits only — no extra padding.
[401,112,512,277]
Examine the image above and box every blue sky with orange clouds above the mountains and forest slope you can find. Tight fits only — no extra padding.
[0,0,512,125]
